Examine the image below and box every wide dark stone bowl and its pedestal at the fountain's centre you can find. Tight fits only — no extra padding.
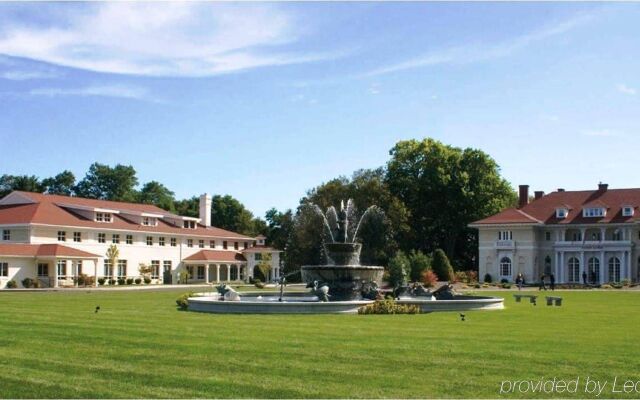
[301,265,384,302]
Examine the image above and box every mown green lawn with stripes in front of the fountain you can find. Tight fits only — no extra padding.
[0,291,640,398]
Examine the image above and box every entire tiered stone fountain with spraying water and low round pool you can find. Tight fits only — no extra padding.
[188,200,504,314]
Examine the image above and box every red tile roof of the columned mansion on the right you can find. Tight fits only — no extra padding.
[471,189,640,226]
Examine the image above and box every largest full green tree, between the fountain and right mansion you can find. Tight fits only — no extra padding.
[386,139,516,269]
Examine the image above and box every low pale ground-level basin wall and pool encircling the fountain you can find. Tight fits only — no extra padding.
[188,292,504,314]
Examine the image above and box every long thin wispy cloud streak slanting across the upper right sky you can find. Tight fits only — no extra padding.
[364,14,593,76]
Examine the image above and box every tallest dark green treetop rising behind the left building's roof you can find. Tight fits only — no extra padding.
[74,163,138,201]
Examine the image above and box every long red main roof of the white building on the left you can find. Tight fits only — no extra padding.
[0,191,254,241]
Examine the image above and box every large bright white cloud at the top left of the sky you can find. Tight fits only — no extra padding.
[0,2,342,76]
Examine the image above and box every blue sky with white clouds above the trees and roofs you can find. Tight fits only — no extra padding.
[0,2,640,216]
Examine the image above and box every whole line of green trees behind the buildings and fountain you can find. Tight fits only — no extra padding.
[0,138,517,271]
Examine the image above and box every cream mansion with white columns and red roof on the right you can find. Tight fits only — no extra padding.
[469,184,640,283]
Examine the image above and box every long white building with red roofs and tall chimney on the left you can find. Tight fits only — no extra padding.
[0,191,280,288]
